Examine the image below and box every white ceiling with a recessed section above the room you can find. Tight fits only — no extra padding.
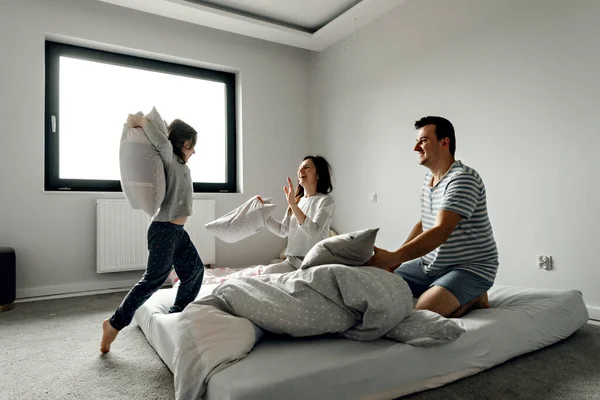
[99,0,405,51]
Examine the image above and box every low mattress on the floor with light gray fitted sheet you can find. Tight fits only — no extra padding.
[135,285,588,400]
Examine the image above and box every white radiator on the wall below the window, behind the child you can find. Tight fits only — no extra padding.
[96,199,215,273]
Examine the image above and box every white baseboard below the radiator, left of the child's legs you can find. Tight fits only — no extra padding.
[16,279,139,303]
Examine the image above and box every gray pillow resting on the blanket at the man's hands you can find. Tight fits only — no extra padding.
[300,228,379,269]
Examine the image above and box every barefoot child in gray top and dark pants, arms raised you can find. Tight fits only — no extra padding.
[100,115,204,353]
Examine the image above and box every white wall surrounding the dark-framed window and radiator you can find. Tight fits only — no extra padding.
[0,0,309,297]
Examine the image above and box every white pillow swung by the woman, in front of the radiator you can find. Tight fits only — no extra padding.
[204,196,277,243]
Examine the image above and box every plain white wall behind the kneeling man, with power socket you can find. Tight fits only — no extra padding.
[309,0,600,318]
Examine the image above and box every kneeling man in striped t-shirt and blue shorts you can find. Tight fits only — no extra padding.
[369,117,498,318]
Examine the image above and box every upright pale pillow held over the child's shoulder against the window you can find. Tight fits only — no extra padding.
[119,107,167,216]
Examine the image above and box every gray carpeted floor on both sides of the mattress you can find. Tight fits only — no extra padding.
[0,293,600,400]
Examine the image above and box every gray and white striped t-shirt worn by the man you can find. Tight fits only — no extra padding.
[421,161,498,282]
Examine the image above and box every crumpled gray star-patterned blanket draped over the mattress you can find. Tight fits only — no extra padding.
[173,264,464,400]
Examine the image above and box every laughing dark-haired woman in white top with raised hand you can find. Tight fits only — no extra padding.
[259,156,335,274]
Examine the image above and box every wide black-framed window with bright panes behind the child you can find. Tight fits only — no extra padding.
[45,41,237,192]
